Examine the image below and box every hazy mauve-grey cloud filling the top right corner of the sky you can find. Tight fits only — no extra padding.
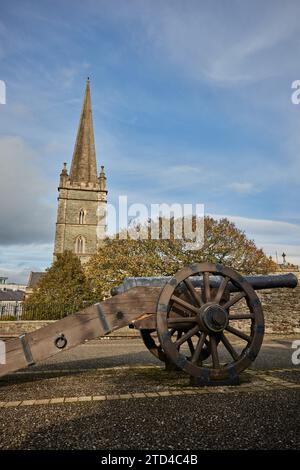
[102,0,300,87]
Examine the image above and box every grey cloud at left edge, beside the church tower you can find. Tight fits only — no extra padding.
[0,136,55,245]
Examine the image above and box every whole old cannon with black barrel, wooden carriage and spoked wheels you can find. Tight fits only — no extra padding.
[0,263,298,386]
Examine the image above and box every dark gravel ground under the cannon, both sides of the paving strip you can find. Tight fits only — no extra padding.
[0,338,300,450]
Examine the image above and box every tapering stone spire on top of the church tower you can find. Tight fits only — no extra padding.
[70,78,97,183]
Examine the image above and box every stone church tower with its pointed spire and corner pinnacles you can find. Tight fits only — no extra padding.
[54,79,107,263]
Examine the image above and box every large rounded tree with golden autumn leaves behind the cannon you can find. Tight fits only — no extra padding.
[85,217,276,300]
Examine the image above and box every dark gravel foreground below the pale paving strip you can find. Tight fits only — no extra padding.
[0,390,300,450]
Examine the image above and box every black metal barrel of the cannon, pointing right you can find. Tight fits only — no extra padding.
[111,273,298,295]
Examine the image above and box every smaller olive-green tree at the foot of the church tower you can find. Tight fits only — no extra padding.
[24,251,94,319]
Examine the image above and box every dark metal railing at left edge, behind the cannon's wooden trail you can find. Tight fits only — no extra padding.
[0,302,82,321]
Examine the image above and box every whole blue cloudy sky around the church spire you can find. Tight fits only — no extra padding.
[0,0,300,282]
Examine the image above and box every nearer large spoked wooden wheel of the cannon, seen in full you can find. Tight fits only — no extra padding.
[157,263,264,384]
